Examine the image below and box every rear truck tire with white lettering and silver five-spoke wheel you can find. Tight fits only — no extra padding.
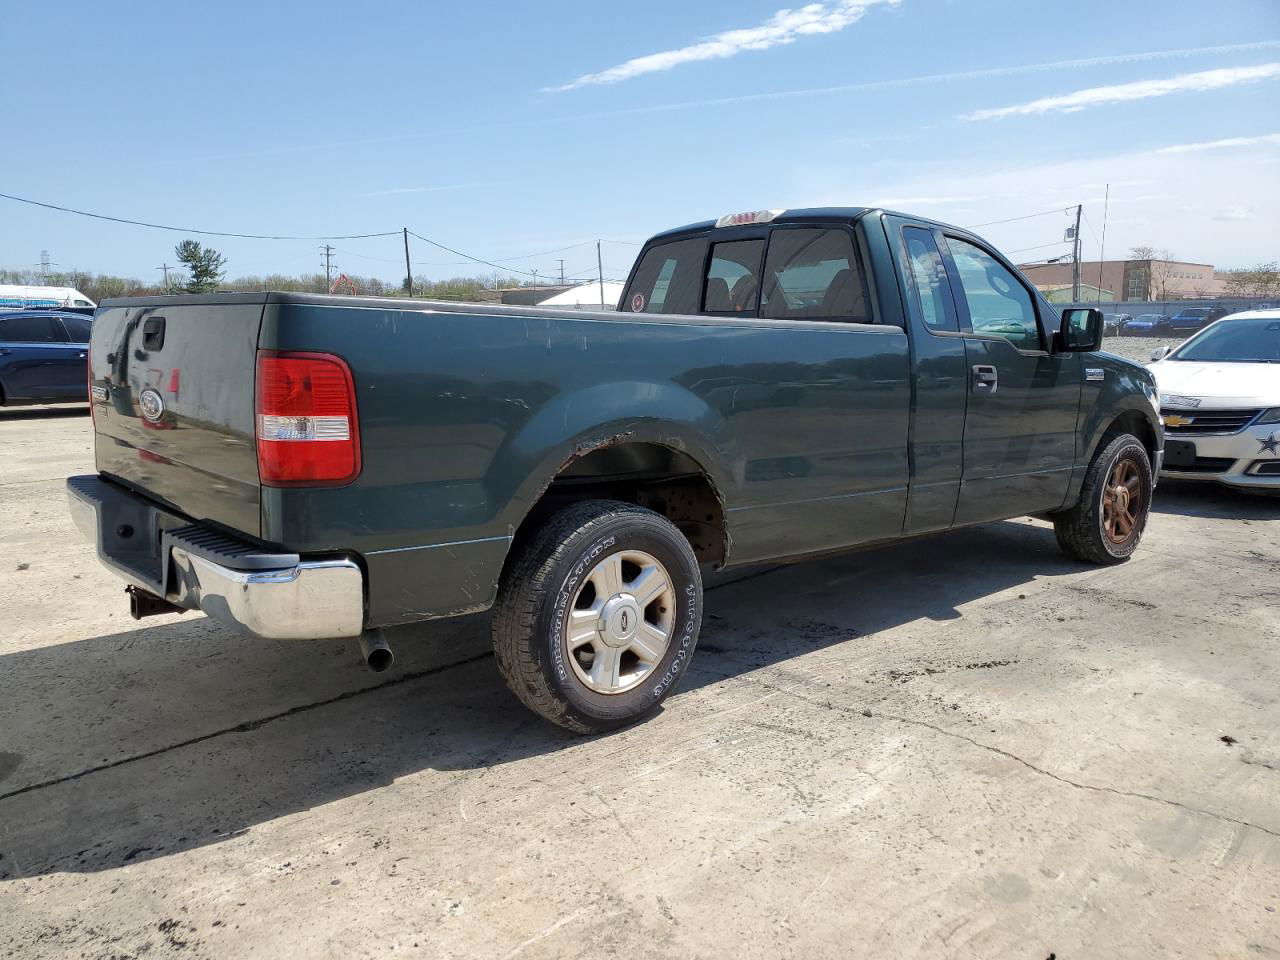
[493,500,703,733]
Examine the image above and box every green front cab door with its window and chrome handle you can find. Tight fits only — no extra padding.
[943,233,1082,525]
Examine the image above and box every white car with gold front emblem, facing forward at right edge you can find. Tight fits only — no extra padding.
[1149,310,1280,490]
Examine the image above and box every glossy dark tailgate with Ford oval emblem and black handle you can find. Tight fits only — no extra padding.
[90,294,265,536]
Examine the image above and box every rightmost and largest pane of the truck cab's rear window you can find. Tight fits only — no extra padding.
[760,228,872,324]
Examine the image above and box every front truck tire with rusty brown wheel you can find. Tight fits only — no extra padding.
[1053,434,1155,564]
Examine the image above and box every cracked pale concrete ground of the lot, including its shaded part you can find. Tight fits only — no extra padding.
[0,411,1280,960]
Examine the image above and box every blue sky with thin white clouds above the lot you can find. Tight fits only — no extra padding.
[0,0,1280,285]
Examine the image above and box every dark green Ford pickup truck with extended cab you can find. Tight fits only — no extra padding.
[68,207,1164,732]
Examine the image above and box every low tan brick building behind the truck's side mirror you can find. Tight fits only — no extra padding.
[1018,260,1224,302]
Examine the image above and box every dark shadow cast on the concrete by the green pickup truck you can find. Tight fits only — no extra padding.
[0,521,1083,881]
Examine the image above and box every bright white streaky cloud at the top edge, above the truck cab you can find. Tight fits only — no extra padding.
[543,0,901,93]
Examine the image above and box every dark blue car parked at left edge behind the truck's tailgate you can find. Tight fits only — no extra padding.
[0,310,92,406]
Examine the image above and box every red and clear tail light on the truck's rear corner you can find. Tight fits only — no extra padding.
[256,351,360,486]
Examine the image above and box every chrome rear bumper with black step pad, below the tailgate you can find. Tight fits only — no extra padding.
[67,476,365,640]
